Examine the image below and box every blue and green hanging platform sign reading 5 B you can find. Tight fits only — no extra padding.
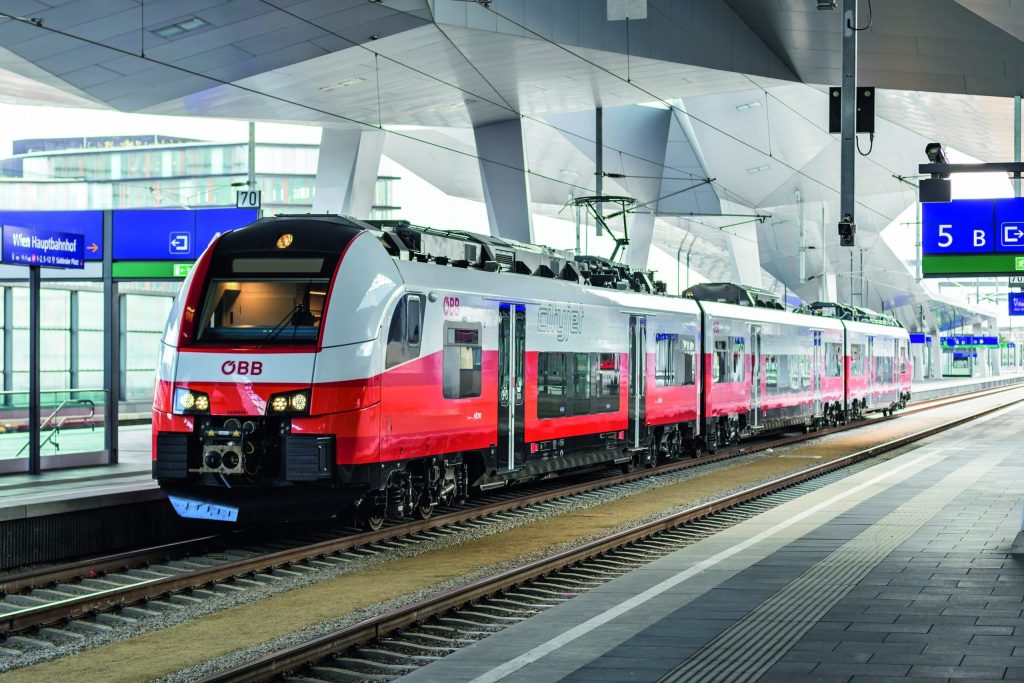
[922,198,1024,278]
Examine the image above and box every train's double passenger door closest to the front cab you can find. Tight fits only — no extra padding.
[498,303,526,473]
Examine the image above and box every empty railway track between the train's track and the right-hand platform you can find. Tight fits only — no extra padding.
[197,389,1024,683]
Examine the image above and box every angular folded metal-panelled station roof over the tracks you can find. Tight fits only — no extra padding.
[0,0,1024,331]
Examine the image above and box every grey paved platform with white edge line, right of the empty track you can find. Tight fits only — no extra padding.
[402,397,1024,683]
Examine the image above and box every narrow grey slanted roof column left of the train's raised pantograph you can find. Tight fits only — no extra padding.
[473,119,534,243]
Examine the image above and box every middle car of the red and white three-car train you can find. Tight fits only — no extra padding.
[684,283,845,452]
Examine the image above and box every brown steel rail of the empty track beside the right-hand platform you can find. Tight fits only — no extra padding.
[196,398,1024,683]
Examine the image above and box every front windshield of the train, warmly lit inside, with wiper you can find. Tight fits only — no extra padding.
[199,278,328,344]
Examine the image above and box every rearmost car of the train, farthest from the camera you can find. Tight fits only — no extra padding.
[807,302,913,420]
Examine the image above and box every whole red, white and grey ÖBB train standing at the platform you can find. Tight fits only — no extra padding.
[153,214,911,528]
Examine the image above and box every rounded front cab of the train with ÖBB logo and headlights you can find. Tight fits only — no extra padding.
[153,218,401,521]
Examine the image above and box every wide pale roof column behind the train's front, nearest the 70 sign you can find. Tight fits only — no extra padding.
[312,128,385,219]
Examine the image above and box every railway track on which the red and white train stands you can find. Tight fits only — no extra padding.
[0,386,1019,654]
